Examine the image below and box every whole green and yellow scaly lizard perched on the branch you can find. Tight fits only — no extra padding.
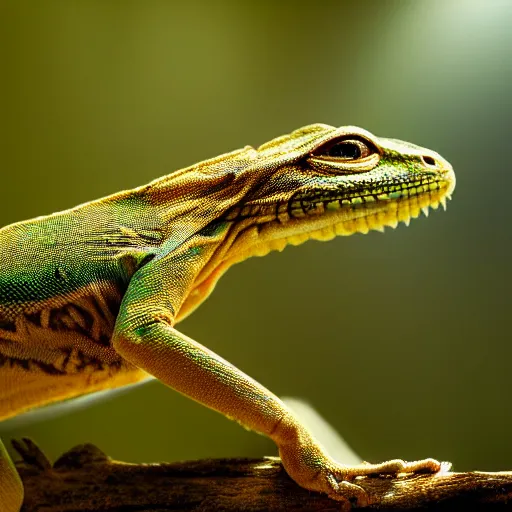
[0,124,455,512]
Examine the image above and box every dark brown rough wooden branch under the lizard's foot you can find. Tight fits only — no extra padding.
[13,439,512,512]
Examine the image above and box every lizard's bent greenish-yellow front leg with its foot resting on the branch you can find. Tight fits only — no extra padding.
[113,243,441,506]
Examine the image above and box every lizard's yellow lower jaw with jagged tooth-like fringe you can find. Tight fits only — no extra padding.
[222,170,455,264]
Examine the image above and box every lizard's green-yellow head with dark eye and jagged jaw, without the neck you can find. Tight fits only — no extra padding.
[220,124,455,261]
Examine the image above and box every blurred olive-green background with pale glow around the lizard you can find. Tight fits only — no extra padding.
[0,0,512,470]
